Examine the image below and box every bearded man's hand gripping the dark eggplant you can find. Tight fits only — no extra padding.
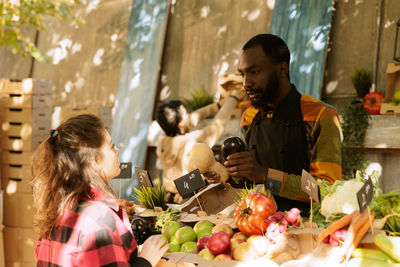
[224,151,267,183]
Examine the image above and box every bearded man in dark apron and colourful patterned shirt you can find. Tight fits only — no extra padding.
[205,34,342,214]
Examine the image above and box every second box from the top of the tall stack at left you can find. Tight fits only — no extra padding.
[0,94,53,108]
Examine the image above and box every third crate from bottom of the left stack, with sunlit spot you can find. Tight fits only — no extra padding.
[0,164,33,194]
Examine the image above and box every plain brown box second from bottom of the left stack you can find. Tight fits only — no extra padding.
[4,193,35,227]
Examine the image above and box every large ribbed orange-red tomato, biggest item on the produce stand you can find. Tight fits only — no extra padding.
[233,192,276,236]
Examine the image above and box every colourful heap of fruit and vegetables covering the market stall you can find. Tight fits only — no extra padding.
[132,173,400,267]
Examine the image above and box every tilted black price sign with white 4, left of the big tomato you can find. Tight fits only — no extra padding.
[174,169,206,198]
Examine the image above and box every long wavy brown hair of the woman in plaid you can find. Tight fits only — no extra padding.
[32,114,115,238]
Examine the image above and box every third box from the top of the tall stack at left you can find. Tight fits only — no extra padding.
[0,107,52,123]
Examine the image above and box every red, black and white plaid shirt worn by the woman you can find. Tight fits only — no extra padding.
[36,188,151,267]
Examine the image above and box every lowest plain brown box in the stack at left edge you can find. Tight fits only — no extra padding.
[4,227,38,266]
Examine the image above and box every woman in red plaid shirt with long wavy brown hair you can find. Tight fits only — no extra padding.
[32,114,168,266]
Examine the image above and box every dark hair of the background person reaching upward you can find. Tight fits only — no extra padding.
[156,99,183,137]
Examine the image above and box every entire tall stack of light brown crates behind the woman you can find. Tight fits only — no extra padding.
[0,79,52,267]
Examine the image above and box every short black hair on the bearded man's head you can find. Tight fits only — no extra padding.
[242,33,290,66]
